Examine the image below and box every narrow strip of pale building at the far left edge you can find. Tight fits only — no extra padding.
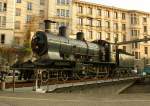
[0,0,15,46]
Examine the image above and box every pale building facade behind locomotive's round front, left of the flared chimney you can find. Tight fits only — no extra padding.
[14,0,47,44]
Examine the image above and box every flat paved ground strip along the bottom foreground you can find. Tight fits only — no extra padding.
[0,93,150,106]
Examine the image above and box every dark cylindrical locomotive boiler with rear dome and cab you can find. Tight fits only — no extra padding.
[32,28,111,62]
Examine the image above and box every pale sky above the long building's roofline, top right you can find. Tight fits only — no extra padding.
[82,0,150,12]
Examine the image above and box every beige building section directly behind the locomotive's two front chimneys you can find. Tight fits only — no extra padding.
[48,0,72,34]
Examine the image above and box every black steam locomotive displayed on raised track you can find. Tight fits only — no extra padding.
[28,26,133,80]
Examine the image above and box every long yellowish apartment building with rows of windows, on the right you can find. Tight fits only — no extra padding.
[71,0,150,67]
